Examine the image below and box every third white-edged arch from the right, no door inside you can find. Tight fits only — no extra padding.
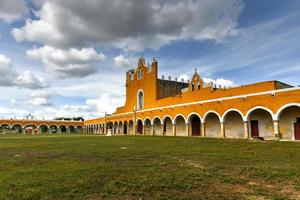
[223,109,245,138]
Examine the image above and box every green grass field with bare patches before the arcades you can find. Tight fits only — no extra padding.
[0,135,300,200]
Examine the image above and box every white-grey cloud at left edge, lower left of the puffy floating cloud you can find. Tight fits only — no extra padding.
[0,54,47,89]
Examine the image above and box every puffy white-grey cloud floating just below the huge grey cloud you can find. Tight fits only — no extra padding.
[26,46,105,78]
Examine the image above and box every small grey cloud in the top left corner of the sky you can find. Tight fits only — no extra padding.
[0,0,27,22]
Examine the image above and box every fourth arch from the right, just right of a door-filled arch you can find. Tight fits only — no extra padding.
[203,111,221,137]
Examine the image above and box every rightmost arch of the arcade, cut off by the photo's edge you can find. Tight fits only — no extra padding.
[276,103,300,140]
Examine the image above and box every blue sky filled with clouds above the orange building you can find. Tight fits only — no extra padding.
[0,0,300,119]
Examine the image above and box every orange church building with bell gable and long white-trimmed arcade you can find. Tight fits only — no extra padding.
[84,58,300,140]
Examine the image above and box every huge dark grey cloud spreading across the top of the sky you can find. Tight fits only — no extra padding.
[12,0,244,51]
